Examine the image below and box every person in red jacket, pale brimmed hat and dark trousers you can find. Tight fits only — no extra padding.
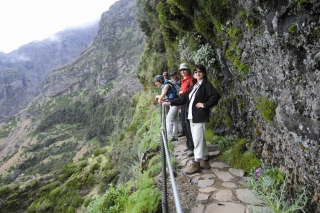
[178,63,196,157]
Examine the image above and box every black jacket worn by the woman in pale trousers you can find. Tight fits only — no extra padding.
[170,79,221,123]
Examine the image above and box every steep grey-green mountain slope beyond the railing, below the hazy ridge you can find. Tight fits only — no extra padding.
[0,1,144,180]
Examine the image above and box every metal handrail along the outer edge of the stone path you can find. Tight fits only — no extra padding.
[161,105,182,213]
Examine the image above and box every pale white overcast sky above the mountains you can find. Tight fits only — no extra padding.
[0,0,117,53]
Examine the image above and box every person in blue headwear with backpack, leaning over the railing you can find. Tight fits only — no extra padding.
[154,75,178,141]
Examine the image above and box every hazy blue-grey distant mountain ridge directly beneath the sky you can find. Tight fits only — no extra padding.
[0,22,98,121]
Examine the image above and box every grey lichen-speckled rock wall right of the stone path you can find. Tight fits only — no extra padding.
[216,0,320,211]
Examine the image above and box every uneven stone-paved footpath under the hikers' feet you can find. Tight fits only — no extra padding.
[170,137,272,213]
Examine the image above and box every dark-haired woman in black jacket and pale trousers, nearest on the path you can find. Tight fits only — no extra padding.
[162,65,221,175]
